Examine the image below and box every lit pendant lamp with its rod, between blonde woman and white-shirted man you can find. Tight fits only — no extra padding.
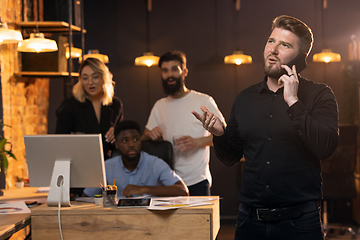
[135,0,159,67]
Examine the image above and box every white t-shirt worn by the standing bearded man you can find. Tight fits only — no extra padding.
[146,90,224,186]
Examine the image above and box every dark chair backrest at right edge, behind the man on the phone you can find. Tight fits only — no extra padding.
[321,125,358,199]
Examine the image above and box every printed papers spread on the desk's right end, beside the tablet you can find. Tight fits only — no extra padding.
[147,197,218,210]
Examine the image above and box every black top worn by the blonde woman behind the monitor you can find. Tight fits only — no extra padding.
[56,97,123,159]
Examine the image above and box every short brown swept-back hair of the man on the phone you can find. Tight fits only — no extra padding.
[271,15,314,55]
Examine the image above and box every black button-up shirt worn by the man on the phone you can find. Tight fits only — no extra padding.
[213,77,338,207]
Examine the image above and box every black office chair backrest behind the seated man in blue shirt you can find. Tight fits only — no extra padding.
[111,141,173,169]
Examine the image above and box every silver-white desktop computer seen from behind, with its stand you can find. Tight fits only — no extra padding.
[24,134,106,207]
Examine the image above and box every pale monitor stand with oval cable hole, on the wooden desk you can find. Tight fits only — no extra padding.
[47,159,71,207]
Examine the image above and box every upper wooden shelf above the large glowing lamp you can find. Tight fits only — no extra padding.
[17,21,86,33]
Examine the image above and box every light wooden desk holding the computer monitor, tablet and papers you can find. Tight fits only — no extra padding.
[31,199,220,240]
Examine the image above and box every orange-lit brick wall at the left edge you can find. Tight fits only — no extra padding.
[0,0,49,187]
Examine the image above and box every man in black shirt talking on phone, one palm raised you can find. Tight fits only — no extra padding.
[193,15,338,240]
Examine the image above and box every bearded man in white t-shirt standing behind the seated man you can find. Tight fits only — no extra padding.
[141,51,226,196]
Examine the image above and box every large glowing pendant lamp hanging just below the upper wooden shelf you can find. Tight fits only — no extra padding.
[18,32,58,53]
